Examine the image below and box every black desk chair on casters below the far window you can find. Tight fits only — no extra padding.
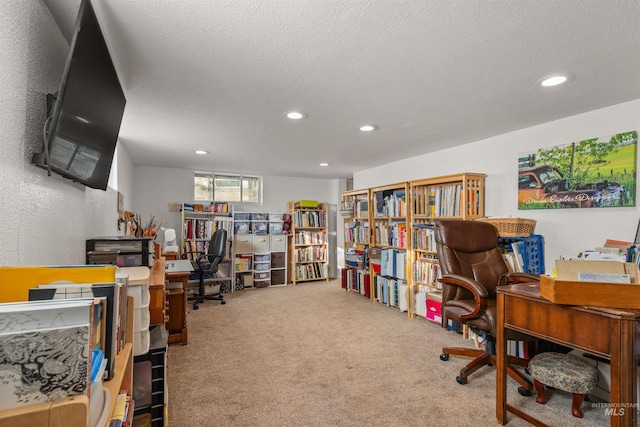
[189,229,227,310]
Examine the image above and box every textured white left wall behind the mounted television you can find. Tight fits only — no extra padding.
[0,1,126,265]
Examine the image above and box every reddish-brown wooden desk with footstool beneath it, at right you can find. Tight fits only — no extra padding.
[496,283,640,427]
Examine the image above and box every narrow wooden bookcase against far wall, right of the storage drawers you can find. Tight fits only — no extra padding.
[288,201,329,285]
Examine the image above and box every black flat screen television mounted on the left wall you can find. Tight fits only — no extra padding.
[32,0,126,190]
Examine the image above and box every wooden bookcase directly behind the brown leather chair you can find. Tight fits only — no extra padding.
[408,172,486,317]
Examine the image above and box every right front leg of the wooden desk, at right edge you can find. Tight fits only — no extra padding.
[610,320,638,427]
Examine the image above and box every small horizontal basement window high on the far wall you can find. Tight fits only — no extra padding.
[193,172,262,203]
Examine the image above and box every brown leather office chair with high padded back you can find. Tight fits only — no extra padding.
[435,220,538,396]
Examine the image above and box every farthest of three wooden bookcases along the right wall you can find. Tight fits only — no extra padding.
[340,189,374,301]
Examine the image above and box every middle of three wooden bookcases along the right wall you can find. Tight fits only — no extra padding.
[369,182,411,311]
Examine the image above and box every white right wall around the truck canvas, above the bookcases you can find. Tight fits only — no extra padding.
[354,100,640,272]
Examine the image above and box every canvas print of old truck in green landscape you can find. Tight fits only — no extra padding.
[518,131,638,210]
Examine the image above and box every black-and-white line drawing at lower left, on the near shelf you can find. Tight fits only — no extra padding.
[0,324,89,410]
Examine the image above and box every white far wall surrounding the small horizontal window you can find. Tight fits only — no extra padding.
[132,166,344,277]
